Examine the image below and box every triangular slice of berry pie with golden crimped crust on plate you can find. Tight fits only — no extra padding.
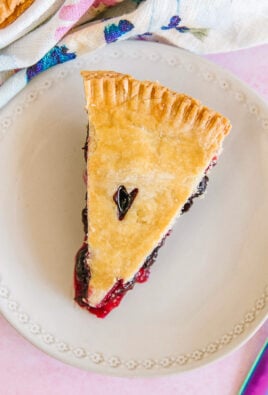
[75,71,231,317]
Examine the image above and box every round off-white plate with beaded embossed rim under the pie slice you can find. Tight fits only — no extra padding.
[0,42,268,375]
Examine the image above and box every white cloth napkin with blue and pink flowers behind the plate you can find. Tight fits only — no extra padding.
[0,0,268,108]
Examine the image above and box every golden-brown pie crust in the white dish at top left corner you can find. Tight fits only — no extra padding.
[0,0,34,29]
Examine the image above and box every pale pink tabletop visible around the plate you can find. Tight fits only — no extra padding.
[0,45,268,395]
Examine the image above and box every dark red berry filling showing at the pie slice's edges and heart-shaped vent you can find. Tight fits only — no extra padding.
[74,129,217,318]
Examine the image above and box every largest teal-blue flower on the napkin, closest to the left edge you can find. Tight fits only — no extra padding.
[26,45,76,82]
